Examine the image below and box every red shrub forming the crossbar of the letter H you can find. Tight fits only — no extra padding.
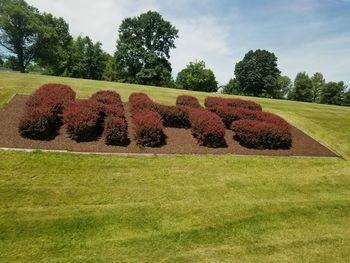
[154,104,190,128]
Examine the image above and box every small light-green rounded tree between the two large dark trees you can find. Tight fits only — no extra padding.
[176,61,218,92]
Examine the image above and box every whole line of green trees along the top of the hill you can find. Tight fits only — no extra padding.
[0,0,350,105]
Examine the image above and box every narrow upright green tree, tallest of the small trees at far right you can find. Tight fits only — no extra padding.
[292,72,313,102]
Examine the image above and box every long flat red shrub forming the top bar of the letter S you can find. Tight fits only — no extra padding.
[204,97,262,111]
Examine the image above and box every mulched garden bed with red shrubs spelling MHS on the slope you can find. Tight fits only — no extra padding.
[0,84,335,156]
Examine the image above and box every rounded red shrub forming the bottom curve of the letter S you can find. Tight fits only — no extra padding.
[231,120,292,149]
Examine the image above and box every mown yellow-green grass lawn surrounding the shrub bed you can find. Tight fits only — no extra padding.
[0,73,350,262]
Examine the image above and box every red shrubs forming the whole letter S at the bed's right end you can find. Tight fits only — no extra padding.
[205,97,292,149]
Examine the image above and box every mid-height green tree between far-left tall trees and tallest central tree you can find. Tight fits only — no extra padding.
[64,36,110,80]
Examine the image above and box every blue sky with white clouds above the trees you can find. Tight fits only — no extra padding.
[27,0,350,86]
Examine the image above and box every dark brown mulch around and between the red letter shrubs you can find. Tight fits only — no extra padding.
[0,95,337,157]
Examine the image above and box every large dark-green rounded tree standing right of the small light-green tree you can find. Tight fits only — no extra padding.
[235,49,281,98]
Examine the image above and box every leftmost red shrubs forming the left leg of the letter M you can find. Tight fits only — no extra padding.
[19,84,76,139]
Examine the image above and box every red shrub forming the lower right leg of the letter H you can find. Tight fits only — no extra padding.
[189,109,226,148]
